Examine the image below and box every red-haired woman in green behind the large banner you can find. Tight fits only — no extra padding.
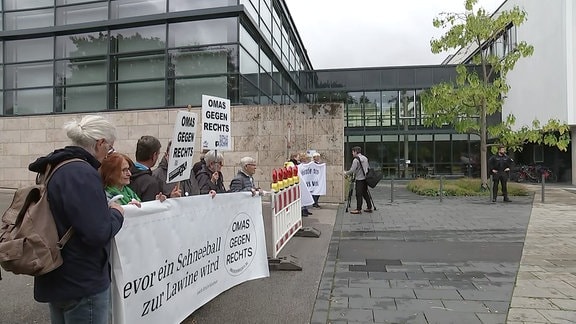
[99,152,141,207]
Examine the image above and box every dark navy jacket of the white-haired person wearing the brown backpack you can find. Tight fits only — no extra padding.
[28,146,124,302]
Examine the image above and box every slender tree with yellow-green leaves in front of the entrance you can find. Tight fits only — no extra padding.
[422,0,570,188]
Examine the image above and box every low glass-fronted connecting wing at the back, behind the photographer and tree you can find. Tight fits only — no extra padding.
[302,65,490,178]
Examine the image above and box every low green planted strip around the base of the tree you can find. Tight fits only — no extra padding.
[406,178,530,197]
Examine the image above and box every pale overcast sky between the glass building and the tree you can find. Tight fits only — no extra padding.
[286,0,504,69]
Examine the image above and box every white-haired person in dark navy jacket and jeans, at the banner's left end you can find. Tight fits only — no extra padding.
[28,115,124,324]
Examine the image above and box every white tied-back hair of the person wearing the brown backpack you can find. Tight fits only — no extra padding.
[63,115,116,153]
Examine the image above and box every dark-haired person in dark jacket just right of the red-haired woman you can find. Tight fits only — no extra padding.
[130,135,180,202]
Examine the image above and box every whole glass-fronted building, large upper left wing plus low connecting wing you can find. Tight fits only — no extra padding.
[0,0,520,178]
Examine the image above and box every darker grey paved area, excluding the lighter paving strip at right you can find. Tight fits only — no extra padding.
[312,185,532,324]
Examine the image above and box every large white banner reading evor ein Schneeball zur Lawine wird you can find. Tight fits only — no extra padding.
[111,192,269,324]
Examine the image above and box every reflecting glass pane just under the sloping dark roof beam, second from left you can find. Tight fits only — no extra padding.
[56,32,108,58]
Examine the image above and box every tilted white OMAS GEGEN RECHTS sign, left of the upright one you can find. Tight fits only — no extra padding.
[166,111,198,183]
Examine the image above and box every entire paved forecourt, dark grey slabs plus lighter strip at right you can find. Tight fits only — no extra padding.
[311,182,576,324]
